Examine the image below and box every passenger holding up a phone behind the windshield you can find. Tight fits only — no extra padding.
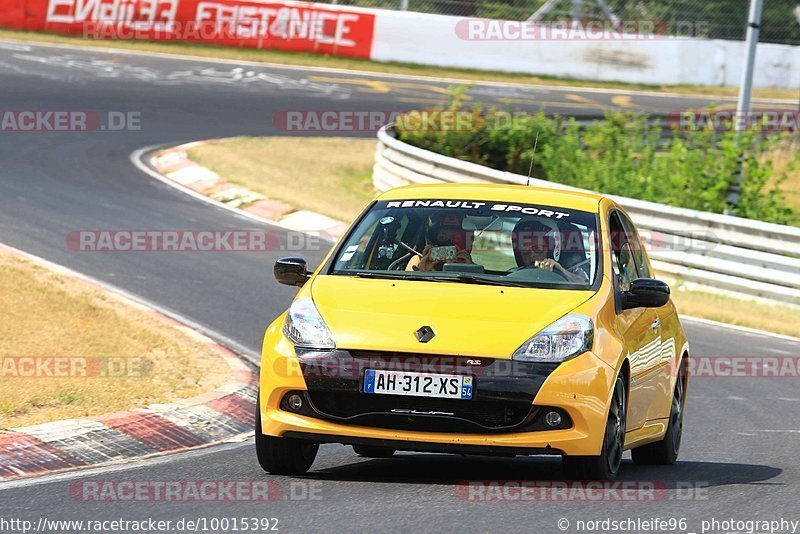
[406,212,473,271]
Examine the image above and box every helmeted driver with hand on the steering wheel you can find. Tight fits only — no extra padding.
[511,219,589,284]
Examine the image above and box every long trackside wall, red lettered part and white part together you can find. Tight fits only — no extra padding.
[12,0,800,88]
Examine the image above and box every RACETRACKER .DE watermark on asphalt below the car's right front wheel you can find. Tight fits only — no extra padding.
[456,480,709,503]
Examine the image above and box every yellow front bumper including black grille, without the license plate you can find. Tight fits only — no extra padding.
[259,327,615,455]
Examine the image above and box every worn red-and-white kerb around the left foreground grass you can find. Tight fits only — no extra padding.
[0,243,258,480]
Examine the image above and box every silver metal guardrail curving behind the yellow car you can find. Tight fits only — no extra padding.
[373,128,800,305]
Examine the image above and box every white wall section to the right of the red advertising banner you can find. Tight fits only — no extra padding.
[370,10,800,88]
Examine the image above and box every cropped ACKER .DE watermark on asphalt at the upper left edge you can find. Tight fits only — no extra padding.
[0,109,142,133]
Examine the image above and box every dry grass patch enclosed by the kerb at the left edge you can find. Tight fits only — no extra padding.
[0,253,230,429]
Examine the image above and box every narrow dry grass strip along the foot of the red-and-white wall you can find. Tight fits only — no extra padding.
[0,30,797,100]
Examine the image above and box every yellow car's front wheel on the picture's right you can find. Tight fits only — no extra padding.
[561,375,628,480]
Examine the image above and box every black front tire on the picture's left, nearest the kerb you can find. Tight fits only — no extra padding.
[255,396,319,475]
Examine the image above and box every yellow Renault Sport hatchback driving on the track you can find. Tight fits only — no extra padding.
[256,184,689,479]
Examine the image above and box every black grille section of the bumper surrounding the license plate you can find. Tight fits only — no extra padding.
[296,350,571,433]
